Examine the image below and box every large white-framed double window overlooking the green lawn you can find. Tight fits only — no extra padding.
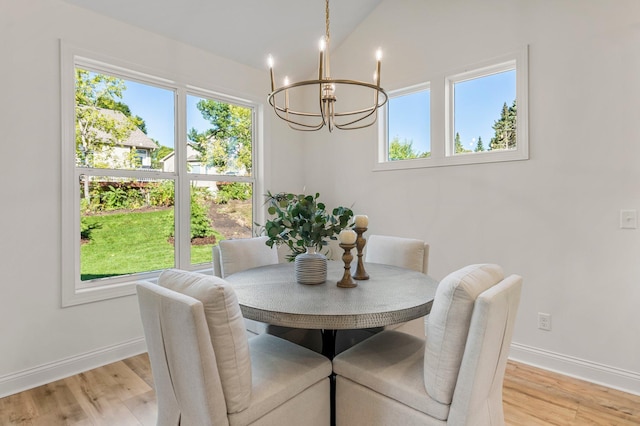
[62,50,256,306]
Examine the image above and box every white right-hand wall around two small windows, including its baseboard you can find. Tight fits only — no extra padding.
[306,0,640,394]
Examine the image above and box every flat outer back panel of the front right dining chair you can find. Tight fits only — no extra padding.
[449,275,522,425]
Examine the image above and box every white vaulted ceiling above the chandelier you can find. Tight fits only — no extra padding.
[64,0,382,75]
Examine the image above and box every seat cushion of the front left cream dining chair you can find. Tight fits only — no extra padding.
[229,334,331,425]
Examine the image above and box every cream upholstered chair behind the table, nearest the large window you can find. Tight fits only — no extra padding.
[213,236,322,352]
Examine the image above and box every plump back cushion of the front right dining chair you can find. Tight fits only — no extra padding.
[424,264,503,404]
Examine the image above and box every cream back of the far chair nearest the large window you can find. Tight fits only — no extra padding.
[218,236,278,278]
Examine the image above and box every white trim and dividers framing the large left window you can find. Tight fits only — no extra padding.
[60,40,264,307]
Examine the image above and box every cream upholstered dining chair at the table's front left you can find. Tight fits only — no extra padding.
[137,270,331,426]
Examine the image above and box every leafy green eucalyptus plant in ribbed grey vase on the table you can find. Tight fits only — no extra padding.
[264,192,353,284]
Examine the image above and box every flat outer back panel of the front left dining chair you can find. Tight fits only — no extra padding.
[136,282,228,426]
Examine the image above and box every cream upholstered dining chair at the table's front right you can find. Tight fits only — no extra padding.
[333,264,522,426]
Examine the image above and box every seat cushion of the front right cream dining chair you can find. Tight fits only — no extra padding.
[333,330,449,420]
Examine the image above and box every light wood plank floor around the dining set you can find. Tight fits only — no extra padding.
[0,354,640,426]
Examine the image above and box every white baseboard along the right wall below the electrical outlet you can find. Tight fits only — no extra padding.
[509,343,640,395]
